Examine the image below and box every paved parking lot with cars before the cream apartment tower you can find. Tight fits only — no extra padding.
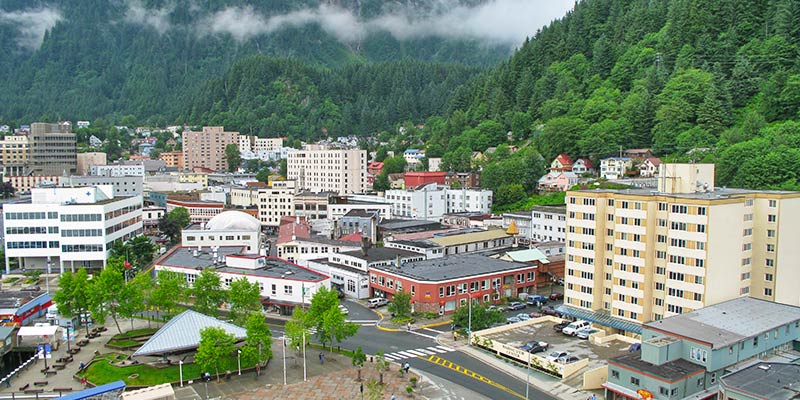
[486,321,629,372]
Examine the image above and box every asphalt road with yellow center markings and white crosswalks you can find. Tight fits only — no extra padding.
[270,300,556,400]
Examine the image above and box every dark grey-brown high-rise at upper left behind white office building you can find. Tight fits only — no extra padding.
[28,122,78,176]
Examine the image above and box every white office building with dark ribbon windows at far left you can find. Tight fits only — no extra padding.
[3,186,142,273]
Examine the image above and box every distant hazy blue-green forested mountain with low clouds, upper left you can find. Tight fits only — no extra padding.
[0,0,511,123]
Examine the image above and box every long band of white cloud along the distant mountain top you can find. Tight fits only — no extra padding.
[138,0,574,47]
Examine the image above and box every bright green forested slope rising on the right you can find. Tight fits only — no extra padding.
[423,0,800,190]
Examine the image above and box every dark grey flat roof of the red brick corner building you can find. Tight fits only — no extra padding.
[372,254,536,281]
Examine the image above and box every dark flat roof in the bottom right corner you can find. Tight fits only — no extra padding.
[722,362,800,400]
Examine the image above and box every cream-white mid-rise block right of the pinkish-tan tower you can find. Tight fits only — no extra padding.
[286,145,368,194]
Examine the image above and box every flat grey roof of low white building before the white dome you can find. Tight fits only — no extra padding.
[156,246,327,281]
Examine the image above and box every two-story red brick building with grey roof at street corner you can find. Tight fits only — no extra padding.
[369,254,537,313]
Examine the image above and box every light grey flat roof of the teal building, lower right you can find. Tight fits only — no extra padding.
[644,297,800,349]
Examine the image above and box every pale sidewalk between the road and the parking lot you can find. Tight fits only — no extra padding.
[436,332,603,400]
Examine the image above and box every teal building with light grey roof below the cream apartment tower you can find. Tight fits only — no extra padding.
[603,298,800,400]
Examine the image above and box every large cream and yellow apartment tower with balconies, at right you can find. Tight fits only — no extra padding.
[563,164,800,333]
